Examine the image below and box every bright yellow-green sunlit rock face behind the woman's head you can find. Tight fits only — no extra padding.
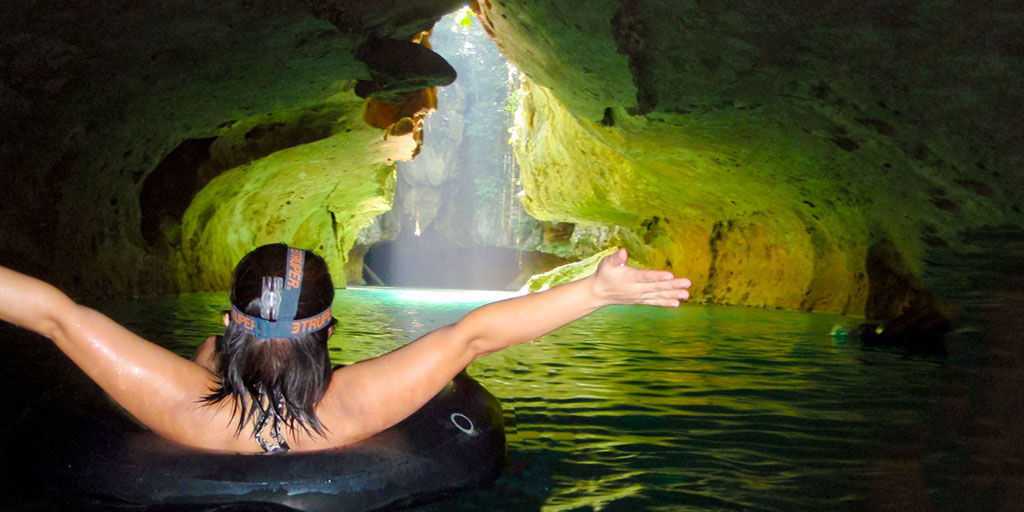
[178,90,416,290]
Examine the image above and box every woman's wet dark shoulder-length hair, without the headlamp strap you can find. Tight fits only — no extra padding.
[201,244,334,437]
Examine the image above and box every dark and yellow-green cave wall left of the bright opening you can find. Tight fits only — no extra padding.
[0,0,457,296]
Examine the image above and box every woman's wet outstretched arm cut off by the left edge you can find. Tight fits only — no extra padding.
[0,266,219,449]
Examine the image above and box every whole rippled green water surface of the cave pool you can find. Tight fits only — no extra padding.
[2,230,1024,511]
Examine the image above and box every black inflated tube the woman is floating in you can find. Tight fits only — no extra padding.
[16,373,505,511]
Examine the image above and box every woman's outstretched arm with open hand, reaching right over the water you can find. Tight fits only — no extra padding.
[321,250,690,442]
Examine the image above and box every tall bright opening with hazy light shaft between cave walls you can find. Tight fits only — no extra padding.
[364,9,542,290]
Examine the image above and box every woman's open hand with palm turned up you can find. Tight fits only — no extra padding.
[591,249,690,307]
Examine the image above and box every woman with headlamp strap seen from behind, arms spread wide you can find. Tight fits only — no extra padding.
[0,245,690,453]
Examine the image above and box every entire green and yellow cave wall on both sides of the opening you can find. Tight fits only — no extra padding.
[0,0,1024,316]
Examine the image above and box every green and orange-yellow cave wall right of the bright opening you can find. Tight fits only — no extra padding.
[475,0,1024,317]
